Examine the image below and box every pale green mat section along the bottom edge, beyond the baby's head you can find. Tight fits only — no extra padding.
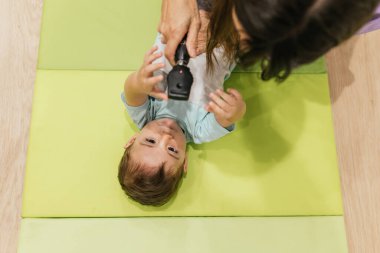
[18,217,348,253]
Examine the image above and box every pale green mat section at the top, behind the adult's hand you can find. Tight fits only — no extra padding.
[38,0,325,73]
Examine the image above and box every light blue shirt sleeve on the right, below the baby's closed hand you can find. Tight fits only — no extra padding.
[193,113,235,144]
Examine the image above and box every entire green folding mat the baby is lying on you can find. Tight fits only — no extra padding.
[19,0,347,253]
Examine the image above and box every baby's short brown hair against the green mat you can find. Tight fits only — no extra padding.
[118,146,183,206]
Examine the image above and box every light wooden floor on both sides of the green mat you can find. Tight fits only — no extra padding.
[0,0,380,253]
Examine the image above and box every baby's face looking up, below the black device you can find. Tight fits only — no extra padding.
[131,118,186,174]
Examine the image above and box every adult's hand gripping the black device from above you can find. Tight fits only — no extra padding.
[158,0,201,65]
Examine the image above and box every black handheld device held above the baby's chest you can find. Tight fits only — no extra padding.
[167,36,193,100]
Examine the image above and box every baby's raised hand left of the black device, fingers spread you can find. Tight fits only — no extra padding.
[136,46,168,100]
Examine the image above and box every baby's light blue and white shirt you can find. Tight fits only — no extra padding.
[121,34,236,144]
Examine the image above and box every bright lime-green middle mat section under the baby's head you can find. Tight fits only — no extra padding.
[22,70,342,217]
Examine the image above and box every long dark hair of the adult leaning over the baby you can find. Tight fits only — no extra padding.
[207,0,380,81]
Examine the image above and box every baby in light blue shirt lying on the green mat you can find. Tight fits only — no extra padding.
[118,34,246,206]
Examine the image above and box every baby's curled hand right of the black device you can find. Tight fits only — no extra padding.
[206,89,246,127]
